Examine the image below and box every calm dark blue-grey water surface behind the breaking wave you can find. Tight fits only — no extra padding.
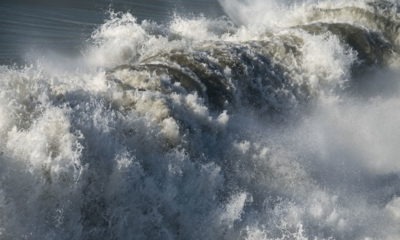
[0,0,222,64]
